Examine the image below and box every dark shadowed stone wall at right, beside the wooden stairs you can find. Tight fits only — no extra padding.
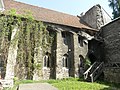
[102,19,120,83]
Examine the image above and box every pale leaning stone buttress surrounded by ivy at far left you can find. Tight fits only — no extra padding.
[5,27,19,80]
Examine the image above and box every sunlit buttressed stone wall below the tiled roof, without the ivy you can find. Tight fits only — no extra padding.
[0,17,95,80]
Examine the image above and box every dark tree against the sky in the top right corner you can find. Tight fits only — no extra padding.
[109,0,120,19]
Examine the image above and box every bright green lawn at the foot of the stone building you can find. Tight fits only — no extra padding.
[5,78,120,90]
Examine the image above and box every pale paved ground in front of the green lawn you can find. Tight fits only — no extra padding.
[18,83,58,90]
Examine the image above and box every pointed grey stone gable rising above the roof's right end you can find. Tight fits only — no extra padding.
[80,5,104,29]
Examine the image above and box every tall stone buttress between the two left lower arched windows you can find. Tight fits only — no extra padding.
[56,31,63,79]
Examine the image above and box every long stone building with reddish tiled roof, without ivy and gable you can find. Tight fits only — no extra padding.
[2,0,98,80]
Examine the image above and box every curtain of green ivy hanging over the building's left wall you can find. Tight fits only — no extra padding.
[0,13,53,79]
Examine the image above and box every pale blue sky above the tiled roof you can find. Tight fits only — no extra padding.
[16,0,112,17]
